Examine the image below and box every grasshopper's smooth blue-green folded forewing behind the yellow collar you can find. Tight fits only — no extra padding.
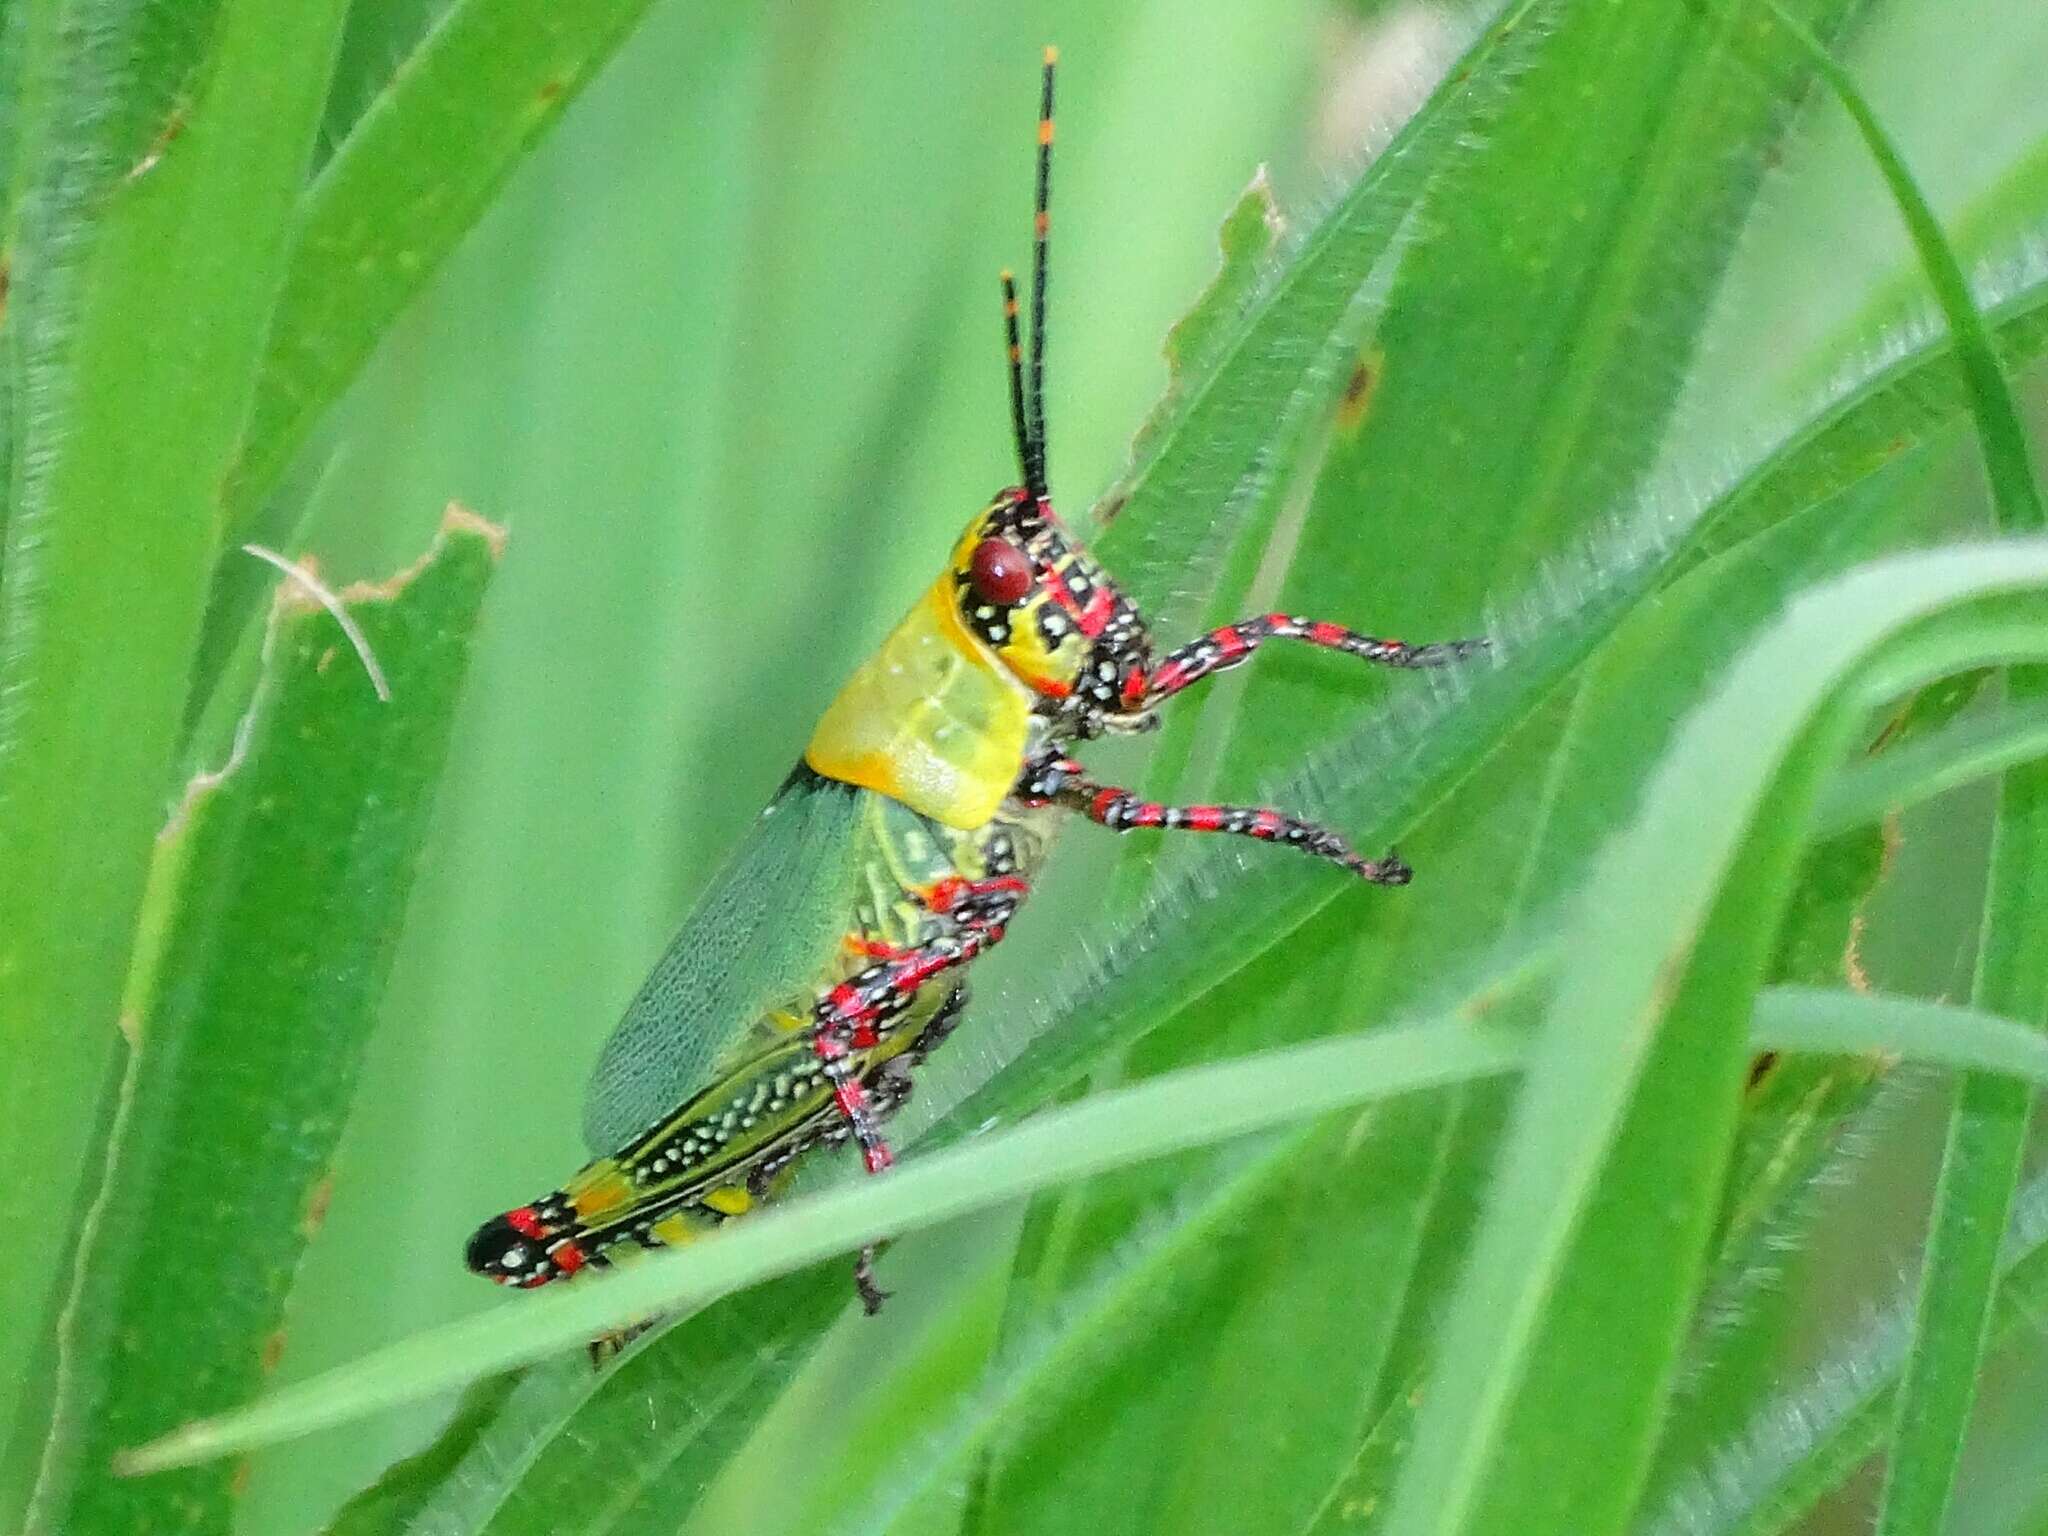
[584,768,868,1153]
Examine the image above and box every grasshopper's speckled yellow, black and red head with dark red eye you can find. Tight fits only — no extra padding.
[952,487,1151,735]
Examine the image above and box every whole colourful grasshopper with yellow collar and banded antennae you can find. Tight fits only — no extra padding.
[467,49,1485,1313]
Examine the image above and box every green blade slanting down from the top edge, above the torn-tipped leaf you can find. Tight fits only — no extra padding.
[227,0,679,530]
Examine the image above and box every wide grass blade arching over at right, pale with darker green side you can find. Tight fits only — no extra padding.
[1391,545,2048,1536]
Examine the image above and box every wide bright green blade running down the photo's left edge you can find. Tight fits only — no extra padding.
[0,0,346,1482]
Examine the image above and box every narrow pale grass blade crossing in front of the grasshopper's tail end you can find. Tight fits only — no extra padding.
[121,1022,1516,1473]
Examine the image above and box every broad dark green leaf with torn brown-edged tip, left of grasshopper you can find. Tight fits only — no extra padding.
[29,510,502,1532]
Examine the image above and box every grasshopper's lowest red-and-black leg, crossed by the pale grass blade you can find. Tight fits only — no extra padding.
[811,874,1030,1313]
